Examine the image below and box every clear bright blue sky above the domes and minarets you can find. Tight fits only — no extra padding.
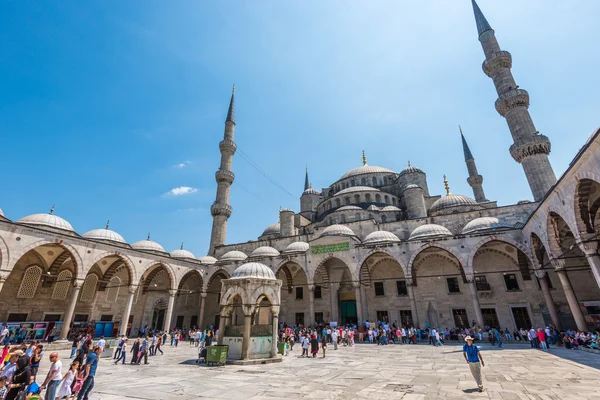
[0,0,600,255]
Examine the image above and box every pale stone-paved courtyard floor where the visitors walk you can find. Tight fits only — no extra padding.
[39,343,600,400]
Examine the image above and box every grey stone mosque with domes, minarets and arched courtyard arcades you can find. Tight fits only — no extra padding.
[0,0,600,338]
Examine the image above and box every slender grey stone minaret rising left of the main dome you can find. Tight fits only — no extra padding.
[208,86,237,255]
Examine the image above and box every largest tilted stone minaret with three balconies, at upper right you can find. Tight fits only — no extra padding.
[471,0,556,201]
